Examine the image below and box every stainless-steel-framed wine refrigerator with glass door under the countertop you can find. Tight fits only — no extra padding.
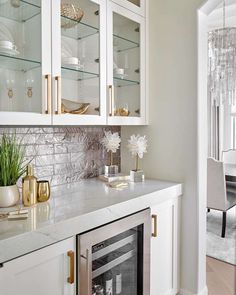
[77,209,151,295]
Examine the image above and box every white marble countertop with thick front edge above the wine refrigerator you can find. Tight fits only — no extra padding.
[0,179,182,263]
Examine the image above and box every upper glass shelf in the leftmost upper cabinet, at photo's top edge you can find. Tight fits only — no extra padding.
[0,0,41,22]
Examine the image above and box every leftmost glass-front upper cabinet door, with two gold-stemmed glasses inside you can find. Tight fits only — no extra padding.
[0,0,51,125]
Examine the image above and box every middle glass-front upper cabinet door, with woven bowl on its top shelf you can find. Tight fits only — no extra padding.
[52,0,106,125]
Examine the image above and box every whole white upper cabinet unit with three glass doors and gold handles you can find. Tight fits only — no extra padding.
[0,0,147,125]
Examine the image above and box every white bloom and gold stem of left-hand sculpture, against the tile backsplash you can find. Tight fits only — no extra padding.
[101,131,121,165]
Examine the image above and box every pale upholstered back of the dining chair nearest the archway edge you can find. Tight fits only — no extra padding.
[207,158,227,211]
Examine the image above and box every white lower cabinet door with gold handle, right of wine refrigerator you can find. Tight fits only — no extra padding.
[151,200,179,295]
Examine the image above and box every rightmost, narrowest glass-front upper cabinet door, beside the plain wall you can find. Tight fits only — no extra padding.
[108,2,146,125]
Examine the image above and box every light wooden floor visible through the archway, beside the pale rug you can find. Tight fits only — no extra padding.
[206,257,236,295]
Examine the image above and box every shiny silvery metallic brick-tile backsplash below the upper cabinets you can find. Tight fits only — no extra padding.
[0,127,120,186]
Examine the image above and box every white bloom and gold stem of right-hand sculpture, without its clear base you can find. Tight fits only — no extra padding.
[128,134,147,171]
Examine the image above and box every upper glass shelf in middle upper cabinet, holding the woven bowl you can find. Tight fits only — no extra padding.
[61,16,99,40]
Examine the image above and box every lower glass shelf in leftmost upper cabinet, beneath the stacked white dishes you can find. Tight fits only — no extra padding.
[0,53,41,72]
